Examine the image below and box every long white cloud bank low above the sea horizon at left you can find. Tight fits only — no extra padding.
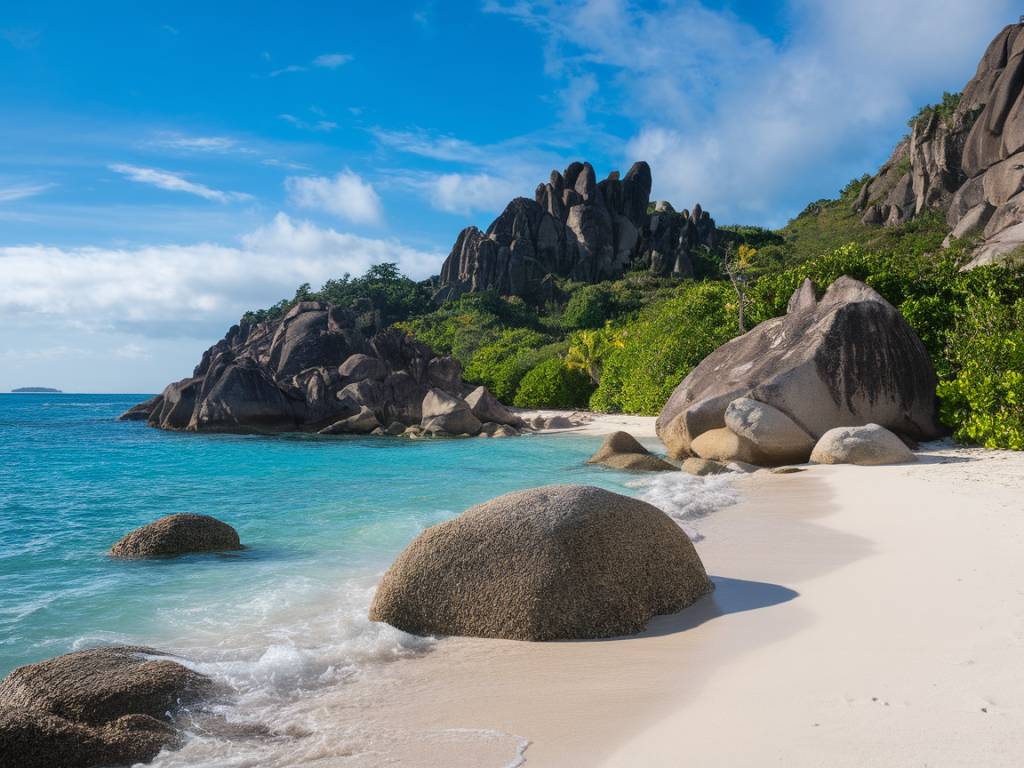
[0,213,443,335]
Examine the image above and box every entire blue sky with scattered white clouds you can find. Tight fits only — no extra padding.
[0,0,1016,391]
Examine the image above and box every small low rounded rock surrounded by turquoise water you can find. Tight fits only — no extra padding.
[111,514,242,558]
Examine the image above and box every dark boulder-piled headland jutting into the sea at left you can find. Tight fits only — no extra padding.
[122,301,485,434]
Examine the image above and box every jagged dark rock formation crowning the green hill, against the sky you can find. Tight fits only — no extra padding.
[437,162,717,301]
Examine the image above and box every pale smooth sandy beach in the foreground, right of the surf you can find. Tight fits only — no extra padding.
[349,449,1024,768]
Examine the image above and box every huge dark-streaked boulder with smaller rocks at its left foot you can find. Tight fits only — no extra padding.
[656,278,941,465]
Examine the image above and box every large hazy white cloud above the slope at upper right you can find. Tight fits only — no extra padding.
[486,0,1017,223]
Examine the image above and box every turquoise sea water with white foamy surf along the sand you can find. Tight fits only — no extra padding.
[0,394,732,768]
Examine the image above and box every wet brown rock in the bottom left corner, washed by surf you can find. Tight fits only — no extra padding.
[0,646,213,768]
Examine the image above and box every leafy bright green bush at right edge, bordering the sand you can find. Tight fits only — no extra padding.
[938,291,1024,451]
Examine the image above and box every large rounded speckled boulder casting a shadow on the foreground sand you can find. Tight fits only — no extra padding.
[370,485,712,640]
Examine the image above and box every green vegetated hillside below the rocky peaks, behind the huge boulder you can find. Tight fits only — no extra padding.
[243,168,1024,450]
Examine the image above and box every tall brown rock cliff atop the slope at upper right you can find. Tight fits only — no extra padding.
[855,24,1024,266]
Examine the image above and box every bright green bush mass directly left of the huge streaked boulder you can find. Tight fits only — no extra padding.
[589,283,736,415]
